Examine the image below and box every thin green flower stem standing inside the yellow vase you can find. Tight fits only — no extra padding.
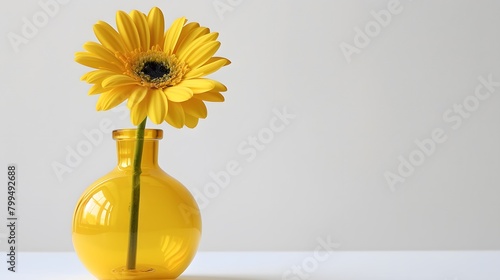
[127,118,147,270]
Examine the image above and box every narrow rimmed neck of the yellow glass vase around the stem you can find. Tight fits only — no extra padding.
[113,129,163,169]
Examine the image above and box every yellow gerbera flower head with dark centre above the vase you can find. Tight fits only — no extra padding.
[75,7,230,128]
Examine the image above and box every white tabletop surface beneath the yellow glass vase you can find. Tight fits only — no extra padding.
[0,251,500,280]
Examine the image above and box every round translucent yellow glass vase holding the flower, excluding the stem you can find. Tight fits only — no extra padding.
[72,129,201,280]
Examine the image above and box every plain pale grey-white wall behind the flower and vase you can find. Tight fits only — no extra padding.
[0,0,500,254]
